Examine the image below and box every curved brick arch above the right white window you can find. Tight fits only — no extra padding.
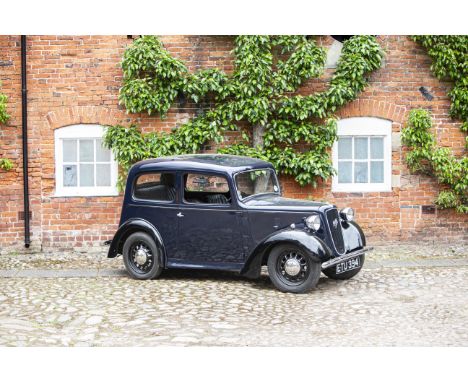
[336,99,408,125]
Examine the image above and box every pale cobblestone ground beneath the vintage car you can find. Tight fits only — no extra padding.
[0,246,468,346]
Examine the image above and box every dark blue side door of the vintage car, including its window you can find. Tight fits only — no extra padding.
[175,172,244,269]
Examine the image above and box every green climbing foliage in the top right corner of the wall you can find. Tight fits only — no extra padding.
[413,35,468,132]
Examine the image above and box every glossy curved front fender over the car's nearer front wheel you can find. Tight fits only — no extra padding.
[241,228,331,278]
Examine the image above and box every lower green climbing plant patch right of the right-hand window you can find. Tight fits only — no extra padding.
[402,109,468,213]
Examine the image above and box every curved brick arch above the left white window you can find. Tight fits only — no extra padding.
[46,106,125,130]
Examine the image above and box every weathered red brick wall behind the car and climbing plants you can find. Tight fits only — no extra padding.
[0,36,468,248]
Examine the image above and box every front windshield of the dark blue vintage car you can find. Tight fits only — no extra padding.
[234,168,280,200]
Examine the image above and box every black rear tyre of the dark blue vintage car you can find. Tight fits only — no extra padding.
[122,232,162,280]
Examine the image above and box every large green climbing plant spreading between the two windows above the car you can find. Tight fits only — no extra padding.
[104,36,383,189]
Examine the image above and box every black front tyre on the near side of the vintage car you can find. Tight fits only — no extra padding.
[268,244,321,293]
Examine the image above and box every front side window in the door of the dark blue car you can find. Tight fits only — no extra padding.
[184,173,231,205]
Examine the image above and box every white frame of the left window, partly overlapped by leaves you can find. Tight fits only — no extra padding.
[54,124,119,197]
